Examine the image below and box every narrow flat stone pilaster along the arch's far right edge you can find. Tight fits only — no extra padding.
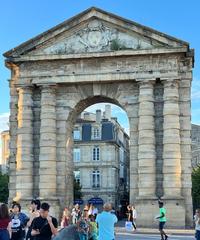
[179,78,193,227]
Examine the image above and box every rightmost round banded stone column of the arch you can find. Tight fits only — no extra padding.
[163,80,181,199]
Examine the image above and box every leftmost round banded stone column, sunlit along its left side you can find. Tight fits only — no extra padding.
[15,86,33,201]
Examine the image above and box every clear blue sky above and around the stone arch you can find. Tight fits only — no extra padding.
[0,0,200,131]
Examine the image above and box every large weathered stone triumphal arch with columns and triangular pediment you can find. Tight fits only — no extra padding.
[4,7,194,226]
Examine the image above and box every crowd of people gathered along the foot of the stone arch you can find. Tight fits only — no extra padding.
[0,199,200,240]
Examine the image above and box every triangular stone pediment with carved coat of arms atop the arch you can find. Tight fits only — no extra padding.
[4,8,188,57]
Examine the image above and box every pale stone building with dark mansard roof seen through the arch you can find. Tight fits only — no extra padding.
[73,105,129,208]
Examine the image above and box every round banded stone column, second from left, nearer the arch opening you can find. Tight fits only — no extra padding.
[39,85,57,199]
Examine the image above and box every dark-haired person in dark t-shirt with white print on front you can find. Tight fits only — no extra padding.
[11,202,29,240]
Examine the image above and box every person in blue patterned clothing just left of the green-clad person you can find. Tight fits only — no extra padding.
[77,209,89,240]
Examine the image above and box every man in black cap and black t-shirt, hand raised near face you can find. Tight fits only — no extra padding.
[31,202,58,240]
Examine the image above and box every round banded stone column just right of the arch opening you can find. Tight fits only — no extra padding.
[138,80,156,198]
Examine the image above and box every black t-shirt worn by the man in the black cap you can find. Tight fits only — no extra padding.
[32,216,58,240]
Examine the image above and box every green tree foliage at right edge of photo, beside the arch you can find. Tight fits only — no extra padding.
[192,167,200,208]
